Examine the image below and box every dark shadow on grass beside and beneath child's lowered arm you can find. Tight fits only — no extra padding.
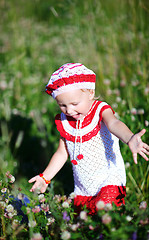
[0,115,73,195]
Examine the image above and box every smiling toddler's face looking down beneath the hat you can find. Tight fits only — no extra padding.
[56,89,94,120]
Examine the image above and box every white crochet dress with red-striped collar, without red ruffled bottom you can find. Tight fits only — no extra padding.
[55,101,126,196]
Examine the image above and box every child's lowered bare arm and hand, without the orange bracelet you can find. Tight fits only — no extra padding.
[29,138,68,192]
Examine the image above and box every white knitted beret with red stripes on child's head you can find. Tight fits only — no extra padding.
[46,63,96,98]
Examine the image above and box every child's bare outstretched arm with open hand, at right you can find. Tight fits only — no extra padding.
[102,109,149,164]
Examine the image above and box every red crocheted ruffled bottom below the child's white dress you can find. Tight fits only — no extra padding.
[74,185,126,215]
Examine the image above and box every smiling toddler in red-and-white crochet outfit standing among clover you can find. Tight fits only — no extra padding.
[29,63,149,214]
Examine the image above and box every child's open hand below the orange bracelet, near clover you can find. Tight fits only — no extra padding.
[28,175,48,193]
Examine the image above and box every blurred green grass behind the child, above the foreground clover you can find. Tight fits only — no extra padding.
[0,0,149,201]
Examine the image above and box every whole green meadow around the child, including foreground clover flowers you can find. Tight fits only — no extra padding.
[0,0,149,240]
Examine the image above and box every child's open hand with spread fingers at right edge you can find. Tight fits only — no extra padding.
[128,129,149,164]
